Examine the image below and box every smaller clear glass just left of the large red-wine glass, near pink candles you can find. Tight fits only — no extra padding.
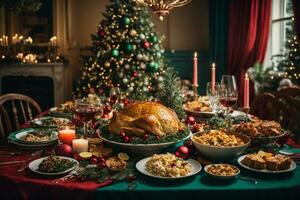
[206,82,220,112]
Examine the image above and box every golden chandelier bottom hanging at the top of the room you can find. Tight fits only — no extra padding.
[135,0,192,21]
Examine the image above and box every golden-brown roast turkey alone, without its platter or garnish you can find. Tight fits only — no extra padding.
[108,101,182,136]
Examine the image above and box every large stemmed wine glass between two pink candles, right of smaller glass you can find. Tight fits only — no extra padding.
[219,75,238,128]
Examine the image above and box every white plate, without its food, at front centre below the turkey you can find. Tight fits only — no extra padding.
[135,157,202,180]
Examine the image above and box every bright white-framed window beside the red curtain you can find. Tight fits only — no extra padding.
[264,0,294,66]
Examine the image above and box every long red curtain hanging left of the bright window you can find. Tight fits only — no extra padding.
[227,0,272,106]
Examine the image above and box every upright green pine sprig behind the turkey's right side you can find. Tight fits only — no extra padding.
[158,67,186,119]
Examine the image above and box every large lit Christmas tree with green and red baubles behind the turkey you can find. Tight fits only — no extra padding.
[77,0,167,99]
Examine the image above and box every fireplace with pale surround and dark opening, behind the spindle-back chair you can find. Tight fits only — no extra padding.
[0,63,68,110]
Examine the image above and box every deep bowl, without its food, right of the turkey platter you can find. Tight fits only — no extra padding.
[191,132,251,161]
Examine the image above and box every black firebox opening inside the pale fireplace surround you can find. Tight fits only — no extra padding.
[1,76,54,110]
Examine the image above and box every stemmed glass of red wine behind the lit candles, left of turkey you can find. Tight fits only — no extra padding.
[75,98,102,137]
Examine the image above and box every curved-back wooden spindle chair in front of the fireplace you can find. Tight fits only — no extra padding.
[0,93,41,141]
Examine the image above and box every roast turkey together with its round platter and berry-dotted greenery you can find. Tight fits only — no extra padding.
[99,101,190,154]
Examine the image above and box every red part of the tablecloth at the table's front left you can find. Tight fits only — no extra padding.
[0,147,111,200]
